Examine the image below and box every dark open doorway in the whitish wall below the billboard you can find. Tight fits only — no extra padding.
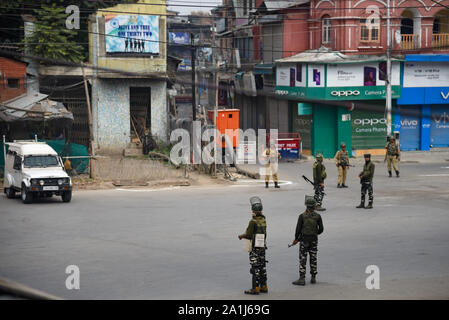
[129,87,151,140]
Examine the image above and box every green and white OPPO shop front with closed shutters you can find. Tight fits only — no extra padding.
[275,53,401,158]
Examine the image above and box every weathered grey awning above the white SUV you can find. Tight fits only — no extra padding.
[0,90,73,122]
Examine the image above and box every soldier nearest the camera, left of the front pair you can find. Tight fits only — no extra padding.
[238,197,268,294]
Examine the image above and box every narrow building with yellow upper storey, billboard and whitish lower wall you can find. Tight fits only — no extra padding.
[89,0,168,153]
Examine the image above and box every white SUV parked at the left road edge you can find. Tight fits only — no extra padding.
[3,141,72,203]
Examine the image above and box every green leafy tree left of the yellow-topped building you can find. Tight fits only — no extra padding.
[24,4,84,62]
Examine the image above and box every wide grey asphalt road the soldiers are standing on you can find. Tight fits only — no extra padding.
[0,162,449,299]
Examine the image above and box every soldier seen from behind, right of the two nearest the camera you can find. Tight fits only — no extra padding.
[292,196,324,286]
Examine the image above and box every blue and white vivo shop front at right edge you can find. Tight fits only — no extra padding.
[395,55,449,150]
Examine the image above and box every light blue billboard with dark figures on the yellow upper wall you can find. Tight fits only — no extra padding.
[105,15,159,54]
